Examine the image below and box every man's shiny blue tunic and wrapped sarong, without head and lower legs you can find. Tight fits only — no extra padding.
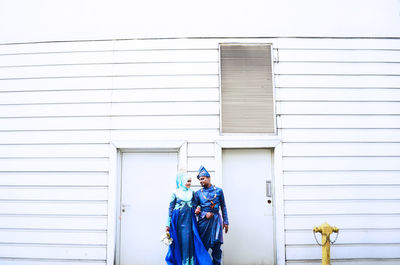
[194,186,229,250]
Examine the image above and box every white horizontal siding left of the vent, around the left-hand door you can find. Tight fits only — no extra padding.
[0,36,219,265]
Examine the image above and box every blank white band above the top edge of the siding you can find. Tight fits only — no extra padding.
[0,0,400,43]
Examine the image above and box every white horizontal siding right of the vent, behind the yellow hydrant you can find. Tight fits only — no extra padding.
[275,42,400,265]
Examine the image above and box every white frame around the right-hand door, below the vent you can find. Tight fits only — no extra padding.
[215,136,285,265]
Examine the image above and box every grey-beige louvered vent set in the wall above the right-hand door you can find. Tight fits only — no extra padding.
[220,44,275,133]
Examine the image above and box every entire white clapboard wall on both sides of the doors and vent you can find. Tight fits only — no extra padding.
[0,38,400,265]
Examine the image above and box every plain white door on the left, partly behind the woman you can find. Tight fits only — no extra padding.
[119,153,178,265]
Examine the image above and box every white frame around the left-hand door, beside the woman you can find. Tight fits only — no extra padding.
[107,140,187,265]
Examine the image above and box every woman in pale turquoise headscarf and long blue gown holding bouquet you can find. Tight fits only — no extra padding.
[165,169,212,265]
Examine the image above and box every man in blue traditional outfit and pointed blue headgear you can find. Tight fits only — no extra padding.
[194,166,229,265]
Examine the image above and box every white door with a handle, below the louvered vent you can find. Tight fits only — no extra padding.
[222,149,275,265]
